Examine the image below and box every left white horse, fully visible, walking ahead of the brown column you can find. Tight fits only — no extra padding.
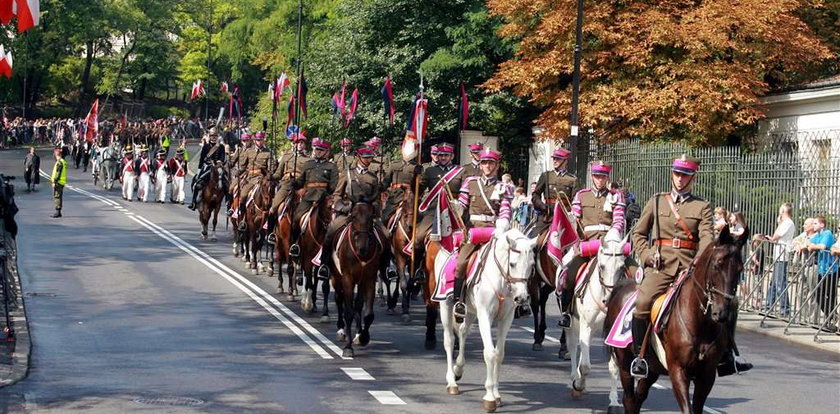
[435,229,537,412]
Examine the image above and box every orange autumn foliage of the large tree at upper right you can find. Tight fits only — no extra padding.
[483,0,833,145]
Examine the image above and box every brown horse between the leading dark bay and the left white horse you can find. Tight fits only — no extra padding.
[379,190,420,323]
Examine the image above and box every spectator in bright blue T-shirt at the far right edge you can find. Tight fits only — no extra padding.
[808,216,838,328]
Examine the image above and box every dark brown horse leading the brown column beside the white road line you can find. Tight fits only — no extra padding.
[330,202,385,357]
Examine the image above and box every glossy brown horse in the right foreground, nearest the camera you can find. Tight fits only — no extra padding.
[604,227,749,414]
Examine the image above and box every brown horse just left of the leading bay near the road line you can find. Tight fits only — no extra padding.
[298,197,332,323]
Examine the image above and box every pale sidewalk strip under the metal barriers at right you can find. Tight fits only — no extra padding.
[738,311,840,355]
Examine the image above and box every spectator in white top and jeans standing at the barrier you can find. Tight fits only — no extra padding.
[766,203,796,316]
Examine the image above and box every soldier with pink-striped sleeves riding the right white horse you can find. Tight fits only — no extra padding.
[556,161,625,328]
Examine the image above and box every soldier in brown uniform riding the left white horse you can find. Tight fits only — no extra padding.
[452,149,513,323]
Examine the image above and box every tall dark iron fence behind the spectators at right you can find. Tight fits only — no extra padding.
[595,129,840,239]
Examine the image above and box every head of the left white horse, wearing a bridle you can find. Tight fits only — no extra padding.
[494,229,537,305]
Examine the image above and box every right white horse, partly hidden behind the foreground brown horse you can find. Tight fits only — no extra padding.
[566,230,626,405]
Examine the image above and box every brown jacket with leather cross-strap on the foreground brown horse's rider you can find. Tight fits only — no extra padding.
[632,193,714,276]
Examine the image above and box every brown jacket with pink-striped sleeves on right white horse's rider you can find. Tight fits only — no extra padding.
[572,188,625,240]
